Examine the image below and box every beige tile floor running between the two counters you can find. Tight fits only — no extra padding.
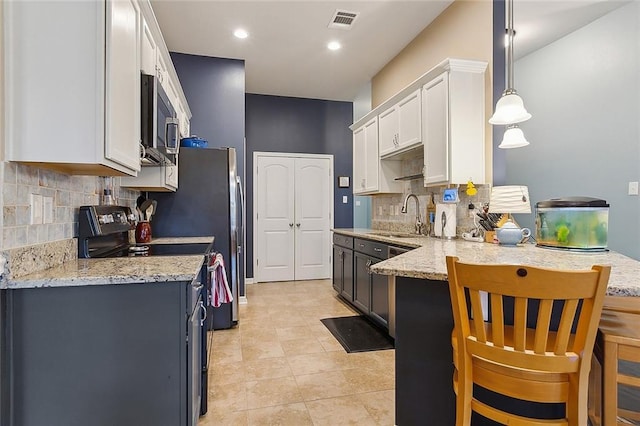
[199,280,395,426]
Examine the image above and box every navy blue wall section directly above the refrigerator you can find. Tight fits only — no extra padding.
[171,53,245,181]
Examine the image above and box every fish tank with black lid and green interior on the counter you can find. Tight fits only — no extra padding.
[536,197,609,251]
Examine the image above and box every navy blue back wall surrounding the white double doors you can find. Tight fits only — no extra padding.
[246,94,353,277]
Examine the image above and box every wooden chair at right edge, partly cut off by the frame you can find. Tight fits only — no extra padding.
[591,308,640,426]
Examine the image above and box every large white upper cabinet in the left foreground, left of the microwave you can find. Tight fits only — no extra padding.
[3,0,141,175]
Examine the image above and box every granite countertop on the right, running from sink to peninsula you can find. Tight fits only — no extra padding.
[333,228,640,296]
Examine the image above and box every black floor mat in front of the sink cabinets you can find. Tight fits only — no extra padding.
[320,315,393,353]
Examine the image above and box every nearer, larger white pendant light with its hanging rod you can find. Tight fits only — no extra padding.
[489,0,531,131]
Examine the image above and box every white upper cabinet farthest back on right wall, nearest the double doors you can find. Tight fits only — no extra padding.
[353,117,402,195]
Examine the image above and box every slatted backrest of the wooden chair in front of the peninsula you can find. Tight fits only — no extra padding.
[447,256,610,375]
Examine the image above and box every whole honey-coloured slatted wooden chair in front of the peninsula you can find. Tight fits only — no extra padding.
[447,256,610,426]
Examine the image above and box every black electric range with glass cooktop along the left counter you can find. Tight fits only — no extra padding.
[78,206,213,415]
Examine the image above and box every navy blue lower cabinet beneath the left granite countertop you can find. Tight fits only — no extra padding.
[3,282,201,426]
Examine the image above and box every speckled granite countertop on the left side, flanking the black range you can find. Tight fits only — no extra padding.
[0,237,213,290]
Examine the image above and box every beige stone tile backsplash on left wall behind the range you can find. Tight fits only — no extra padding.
[0,162,139,250]
